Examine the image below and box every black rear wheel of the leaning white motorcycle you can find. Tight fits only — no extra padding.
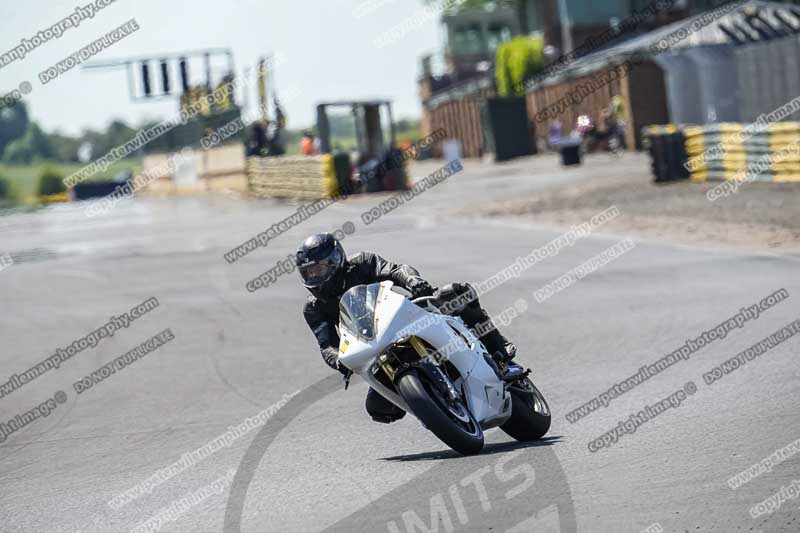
[500,378,550,441]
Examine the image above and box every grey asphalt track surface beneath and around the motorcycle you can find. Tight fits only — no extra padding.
[0,152,800,533]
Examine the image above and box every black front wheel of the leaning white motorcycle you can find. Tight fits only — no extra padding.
[397,371,483,455]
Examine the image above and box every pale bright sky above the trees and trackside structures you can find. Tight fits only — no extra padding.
[0,0,442,135]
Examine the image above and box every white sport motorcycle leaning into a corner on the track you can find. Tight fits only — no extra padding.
[339,281,550,455]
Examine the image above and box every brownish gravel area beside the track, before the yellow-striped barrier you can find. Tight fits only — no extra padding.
[472,154,800,254]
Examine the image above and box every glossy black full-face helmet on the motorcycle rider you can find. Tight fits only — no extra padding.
[295,233,347,299]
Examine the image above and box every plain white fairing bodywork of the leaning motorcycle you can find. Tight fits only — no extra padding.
[339,281,511,429]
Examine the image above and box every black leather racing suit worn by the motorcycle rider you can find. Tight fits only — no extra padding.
[303,252,505,423]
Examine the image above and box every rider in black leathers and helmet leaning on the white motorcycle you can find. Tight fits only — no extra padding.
[295,233,516,424]
